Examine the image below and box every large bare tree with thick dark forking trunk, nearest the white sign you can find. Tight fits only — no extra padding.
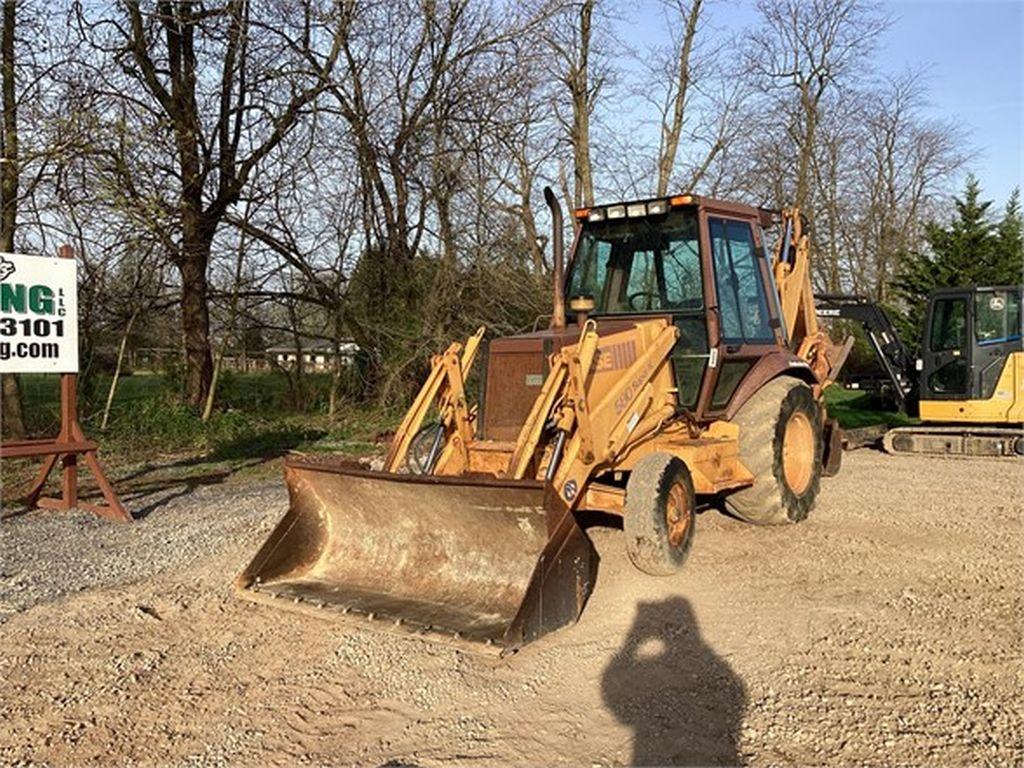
[74,0,339,408]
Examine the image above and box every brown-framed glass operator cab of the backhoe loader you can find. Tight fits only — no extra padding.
[565,195,784,416]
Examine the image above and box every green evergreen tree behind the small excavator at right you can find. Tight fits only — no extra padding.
[893,176,1024,347]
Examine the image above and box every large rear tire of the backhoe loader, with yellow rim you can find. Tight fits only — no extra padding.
[725,378,823,525]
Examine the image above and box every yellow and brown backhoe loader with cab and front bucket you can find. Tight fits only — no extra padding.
[237,189,852,650]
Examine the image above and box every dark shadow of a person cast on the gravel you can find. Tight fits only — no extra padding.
[601,597,746,766]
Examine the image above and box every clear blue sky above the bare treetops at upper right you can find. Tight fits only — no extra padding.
[618,0,1024,207]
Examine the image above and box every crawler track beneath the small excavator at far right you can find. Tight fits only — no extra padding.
[882,425,1024,457]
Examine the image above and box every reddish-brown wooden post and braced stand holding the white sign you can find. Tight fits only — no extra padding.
[0,246,132,522]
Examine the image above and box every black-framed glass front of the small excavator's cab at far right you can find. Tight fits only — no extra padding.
[921,293,972,400]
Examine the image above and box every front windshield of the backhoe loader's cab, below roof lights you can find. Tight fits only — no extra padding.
[568,209,703,314]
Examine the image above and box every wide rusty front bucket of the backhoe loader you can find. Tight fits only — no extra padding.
[238,459,597,647]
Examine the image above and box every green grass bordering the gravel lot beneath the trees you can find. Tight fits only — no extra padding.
[3,373,914,505]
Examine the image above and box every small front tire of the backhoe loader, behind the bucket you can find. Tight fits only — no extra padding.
[623,454,696,575]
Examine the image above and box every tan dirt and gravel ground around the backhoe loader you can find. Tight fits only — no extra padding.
[0,451,1024,766]
